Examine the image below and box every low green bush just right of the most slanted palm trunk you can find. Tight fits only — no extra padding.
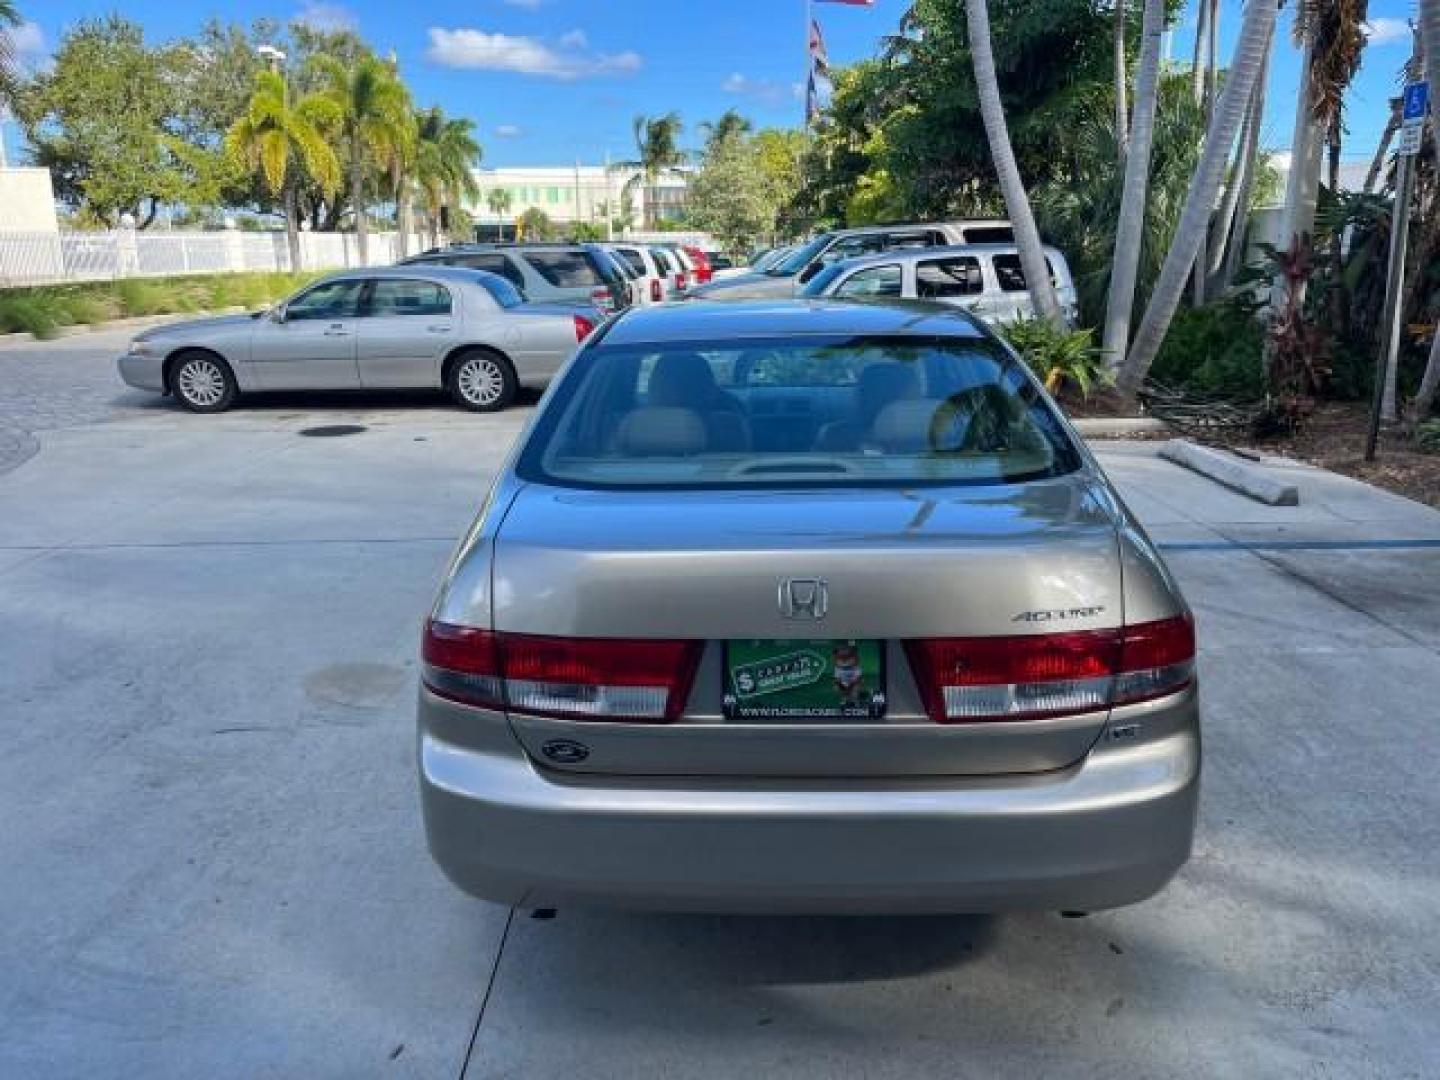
[1149,301,1266,400]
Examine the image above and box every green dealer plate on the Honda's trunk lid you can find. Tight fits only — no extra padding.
[724,638,886,721]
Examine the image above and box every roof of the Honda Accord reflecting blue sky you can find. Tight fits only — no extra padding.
[602,300,988,346]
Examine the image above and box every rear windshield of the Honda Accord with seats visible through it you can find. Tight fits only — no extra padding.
[517,337,1080,490]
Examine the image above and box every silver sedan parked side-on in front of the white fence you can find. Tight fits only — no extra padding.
[120,266,602,412]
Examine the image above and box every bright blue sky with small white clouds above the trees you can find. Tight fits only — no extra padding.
[12,0,1416,166]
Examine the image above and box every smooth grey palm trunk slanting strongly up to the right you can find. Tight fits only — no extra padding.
[1117,0,1290,397]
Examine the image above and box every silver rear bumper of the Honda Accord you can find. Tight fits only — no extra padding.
[419,690,1201,913]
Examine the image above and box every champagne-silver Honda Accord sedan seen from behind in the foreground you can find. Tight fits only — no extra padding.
[419,301,1201,913]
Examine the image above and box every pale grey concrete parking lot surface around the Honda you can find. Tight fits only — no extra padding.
[0,334,1440,1079]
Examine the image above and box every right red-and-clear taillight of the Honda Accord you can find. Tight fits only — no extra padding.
[906,615,1195,723]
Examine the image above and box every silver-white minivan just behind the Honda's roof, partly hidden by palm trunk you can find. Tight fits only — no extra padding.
[801,243,1079,325]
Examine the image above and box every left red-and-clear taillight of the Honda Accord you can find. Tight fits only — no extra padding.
[423,622,703,723]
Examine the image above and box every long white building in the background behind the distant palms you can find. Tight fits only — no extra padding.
[468,164,685,235]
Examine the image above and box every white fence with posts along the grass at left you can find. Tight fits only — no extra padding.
[0,229,428,287]
